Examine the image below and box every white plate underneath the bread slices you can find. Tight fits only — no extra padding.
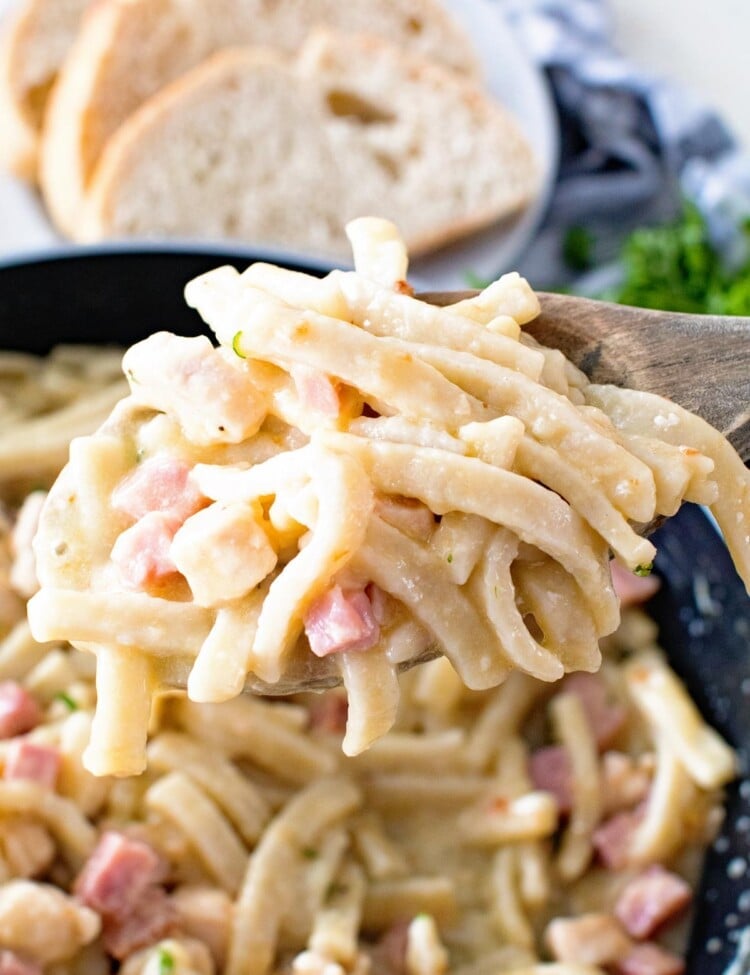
[0,0,558,289]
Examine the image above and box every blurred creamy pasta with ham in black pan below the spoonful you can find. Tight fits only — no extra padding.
[0,324,735,975]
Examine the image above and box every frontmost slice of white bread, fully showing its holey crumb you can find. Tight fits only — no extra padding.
[79,32,536,258]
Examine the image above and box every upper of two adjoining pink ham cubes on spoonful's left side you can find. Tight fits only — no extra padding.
[112,457,207,524]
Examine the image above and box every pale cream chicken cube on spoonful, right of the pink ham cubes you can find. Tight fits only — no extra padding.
[170,503,277,606]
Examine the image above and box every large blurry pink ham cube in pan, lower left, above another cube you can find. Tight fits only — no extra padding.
[74,832,160,919]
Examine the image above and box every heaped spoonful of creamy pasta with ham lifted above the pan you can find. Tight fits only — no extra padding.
[29,218,750,774]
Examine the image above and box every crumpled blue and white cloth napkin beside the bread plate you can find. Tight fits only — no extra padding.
[500,0,750,287]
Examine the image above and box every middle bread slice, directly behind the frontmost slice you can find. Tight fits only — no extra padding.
[41,0,478,234]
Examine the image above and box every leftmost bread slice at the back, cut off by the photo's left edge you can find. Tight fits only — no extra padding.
[0,0,90,180]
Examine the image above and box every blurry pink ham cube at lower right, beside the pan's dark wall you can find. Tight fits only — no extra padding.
[615,864,692,941]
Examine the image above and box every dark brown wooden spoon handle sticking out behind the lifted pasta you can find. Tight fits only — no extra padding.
[419,291,750,463]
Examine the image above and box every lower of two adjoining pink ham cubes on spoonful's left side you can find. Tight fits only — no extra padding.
[111,511,180,589]
